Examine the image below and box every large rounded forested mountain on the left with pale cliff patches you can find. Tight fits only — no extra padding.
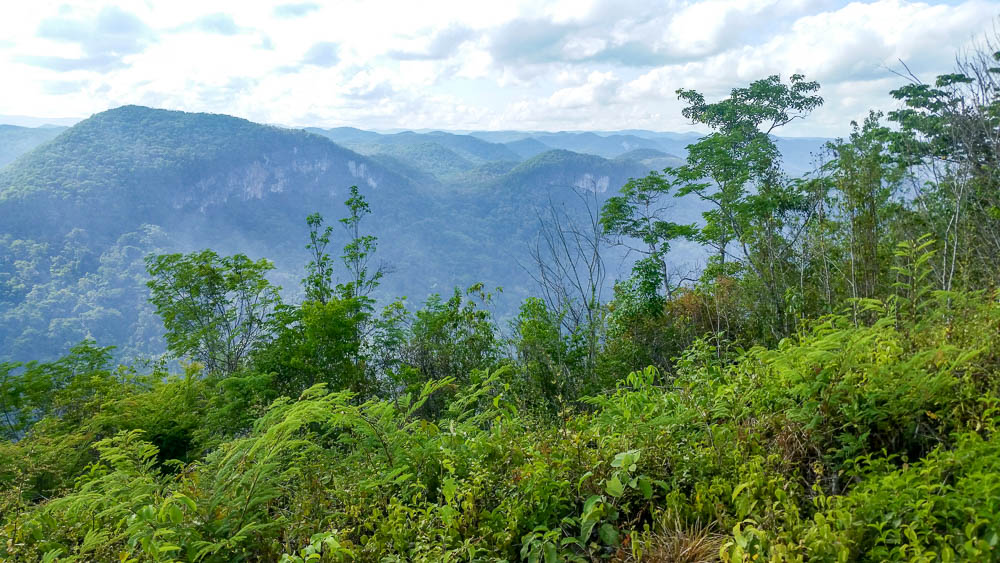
[0,106,434,358]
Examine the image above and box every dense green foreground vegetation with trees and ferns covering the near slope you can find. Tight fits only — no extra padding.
[0,45,1000,563]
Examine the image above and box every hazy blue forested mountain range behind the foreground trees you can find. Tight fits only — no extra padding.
[0,106,732,358]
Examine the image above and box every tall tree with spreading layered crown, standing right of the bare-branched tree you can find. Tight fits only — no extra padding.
[664,74,823,337]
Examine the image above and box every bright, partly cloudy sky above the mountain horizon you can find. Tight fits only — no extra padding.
[0,0,1000,137]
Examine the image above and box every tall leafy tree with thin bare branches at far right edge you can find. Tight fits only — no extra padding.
[889,43,1000,289]
